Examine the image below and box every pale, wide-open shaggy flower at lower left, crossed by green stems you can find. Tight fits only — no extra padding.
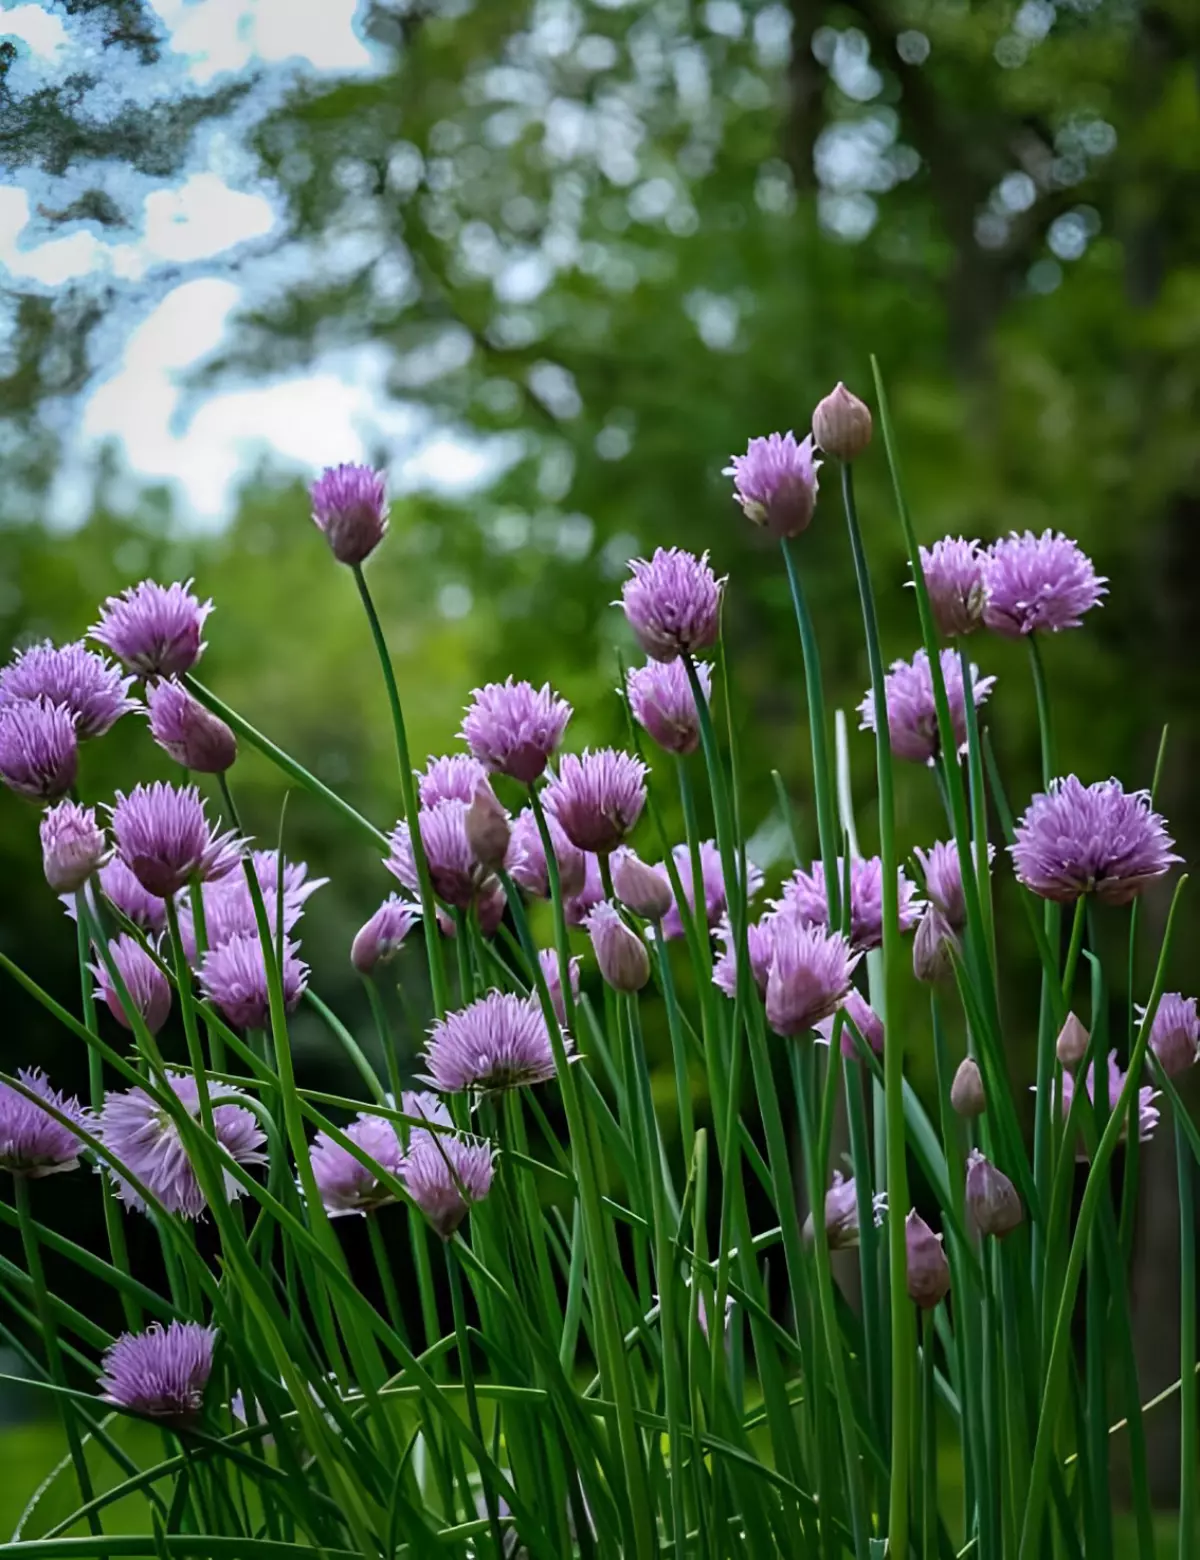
[97,1073,267,1218]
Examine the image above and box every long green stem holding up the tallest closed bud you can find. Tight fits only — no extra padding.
[825,465,911,1555]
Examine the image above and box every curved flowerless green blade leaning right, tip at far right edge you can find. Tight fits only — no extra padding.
[1019,877,1188,1560]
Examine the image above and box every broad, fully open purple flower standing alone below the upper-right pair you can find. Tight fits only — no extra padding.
[1010,775,1180,905]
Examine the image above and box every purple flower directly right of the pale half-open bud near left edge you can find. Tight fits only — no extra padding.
[112,780,242,899]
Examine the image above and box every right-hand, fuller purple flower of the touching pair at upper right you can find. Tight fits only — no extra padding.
[983,530,1108,640]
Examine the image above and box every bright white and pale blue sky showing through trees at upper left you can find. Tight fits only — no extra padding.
[0,0,496,526]
